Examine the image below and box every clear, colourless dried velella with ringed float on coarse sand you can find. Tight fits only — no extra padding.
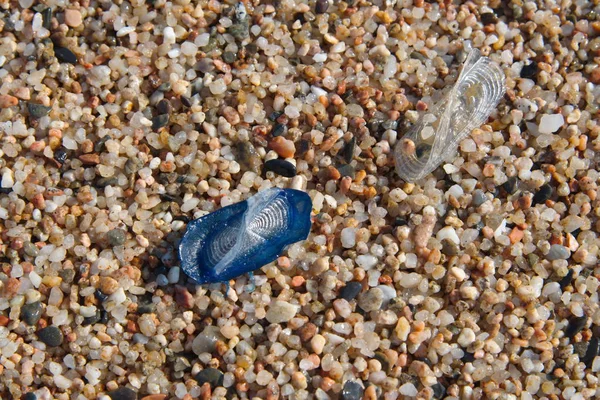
[394,49,505,182]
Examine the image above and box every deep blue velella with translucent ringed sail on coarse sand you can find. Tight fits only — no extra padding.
[179,188,312,284]
